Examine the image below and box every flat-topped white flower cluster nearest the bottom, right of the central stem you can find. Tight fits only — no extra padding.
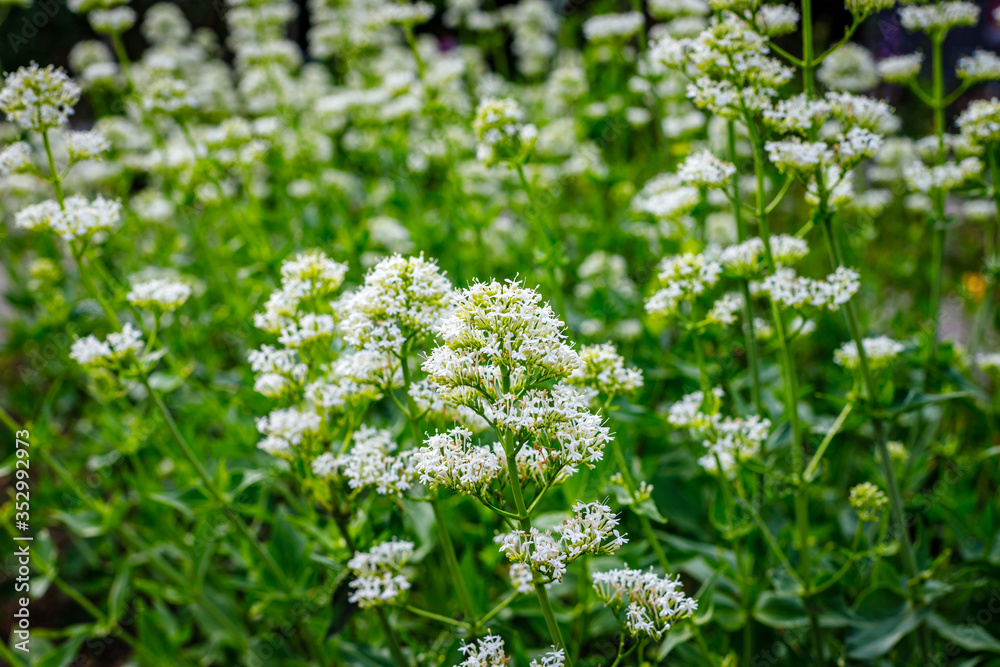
[594,567,698,639]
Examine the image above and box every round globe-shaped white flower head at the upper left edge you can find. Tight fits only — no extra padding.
[0,63,80,132]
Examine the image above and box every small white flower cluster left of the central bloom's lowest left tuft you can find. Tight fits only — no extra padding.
[312,426,416,495]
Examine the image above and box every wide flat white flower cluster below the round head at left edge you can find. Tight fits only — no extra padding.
[14,195,122,243]
